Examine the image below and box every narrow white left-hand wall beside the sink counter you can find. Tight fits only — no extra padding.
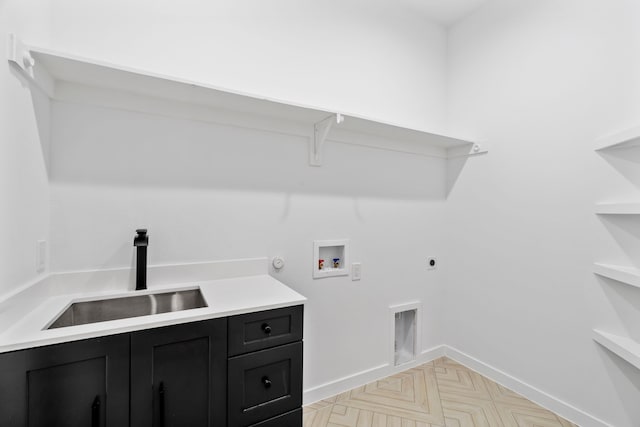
[0,0,49,296]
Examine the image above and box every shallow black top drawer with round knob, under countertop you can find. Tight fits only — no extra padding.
[228,305,303,356]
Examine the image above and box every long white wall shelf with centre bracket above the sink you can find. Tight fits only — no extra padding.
[9,35,486,166]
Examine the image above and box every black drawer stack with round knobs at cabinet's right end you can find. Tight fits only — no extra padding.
[227,305,303,427]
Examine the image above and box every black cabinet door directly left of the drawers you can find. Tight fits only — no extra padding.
[131,319,227,427]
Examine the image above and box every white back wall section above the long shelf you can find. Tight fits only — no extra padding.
[52,0,446,130]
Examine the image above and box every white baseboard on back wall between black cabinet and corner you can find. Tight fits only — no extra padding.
[302,345,445,405]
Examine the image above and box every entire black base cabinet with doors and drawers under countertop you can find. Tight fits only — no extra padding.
[0,306,302,427]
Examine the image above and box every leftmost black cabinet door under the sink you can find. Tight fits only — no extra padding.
[0,335,129,427]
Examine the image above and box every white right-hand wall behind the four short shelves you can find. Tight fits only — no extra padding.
[443,0,640,427]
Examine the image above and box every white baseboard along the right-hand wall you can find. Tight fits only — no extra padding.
[443,346,612,427]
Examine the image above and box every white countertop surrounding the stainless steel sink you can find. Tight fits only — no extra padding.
[0,274,306,353]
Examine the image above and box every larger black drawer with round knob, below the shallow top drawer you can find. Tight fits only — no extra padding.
[228,342,302,427]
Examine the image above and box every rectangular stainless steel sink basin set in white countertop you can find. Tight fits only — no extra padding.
[47,289,207,329]
